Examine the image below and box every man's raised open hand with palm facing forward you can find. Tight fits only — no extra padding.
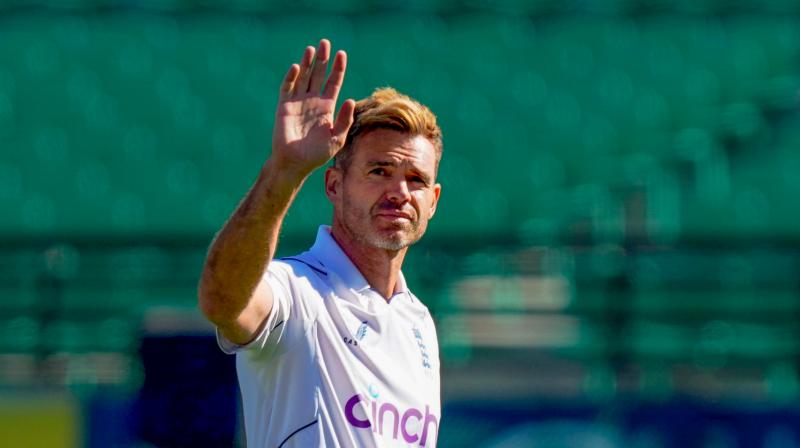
[272,39,355,175]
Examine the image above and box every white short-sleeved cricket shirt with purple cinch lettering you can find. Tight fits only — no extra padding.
[218,226,441,448]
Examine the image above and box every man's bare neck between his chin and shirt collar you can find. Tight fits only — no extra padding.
[331,222,408,301]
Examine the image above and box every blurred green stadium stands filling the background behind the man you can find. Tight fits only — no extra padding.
[0,0,800,447]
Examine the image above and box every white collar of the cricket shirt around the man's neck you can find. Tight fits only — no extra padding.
[309,225,408,295]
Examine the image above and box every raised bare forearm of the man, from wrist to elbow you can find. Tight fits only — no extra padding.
[198,159,306,325]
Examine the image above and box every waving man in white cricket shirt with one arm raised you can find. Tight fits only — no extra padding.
[199,39,442,448]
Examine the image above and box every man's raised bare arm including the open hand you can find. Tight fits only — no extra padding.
[198,39,355,344]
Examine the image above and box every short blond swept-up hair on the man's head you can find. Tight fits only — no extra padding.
[333,87,442,171]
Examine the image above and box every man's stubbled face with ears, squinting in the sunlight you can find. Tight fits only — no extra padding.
[325,129,441,251]
